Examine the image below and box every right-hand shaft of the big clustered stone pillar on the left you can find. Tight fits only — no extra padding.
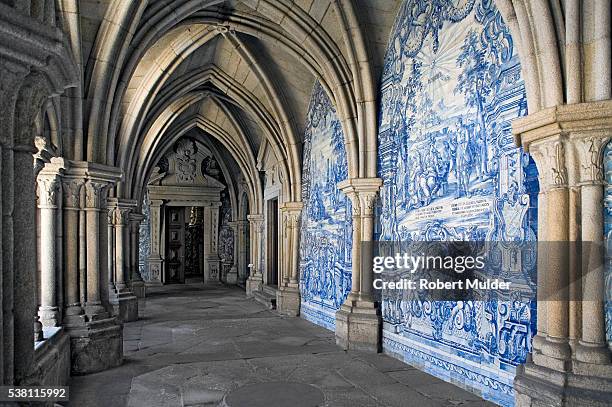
[85,180,109,319]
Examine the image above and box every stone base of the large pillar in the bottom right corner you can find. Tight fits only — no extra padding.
[514,360,612,407]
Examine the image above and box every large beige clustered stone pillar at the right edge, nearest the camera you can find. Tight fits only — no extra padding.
[513,101,612,407]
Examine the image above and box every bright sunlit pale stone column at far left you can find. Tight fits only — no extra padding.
[37,164,63,326]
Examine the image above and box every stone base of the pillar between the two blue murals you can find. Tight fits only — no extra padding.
[336,296,382,352]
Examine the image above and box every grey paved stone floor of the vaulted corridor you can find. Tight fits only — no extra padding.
[68,283,491,407]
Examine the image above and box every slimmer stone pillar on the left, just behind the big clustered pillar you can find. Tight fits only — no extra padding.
[108,198,138,322]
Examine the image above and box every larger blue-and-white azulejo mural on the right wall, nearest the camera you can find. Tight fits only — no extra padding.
[376,0,538,405]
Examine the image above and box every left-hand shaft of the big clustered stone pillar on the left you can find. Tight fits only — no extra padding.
[62,177,85,325]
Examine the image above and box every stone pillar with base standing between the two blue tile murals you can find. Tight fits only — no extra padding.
[336,178,382,352]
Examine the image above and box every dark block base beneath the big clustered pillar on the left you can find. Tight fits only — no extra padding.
[66,318,123,375]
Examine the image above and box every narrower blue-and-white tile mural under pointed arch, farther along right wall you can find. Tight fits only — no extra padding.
[300,82,352,330]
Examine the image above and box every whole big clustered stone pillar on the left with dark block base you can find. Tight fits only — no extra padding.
[64,161,123,374]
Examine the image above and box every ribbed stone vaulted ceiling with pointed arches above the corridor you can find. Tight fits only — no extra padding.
[79,0,399,210]
